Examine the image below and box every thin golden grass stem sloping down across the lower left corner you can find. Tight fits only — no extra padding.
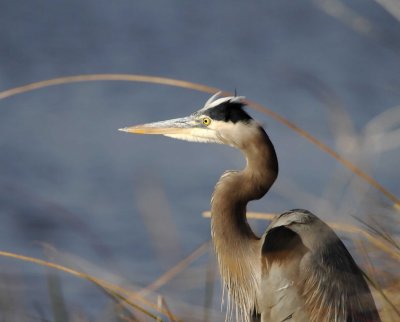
[0,251,178,321]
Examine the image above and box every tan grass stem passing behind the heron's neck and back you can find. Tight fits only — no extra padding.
[202,211,400,260]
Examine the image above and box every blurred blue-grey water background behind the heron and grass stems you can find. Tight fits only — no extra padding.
[0,0,400,321]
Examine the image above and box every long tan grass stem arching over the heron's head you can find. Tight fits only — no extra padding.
[0,74,400,206]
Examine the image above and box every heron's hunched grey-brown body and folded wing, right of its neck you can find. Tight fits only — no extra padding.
[260,210,380,322]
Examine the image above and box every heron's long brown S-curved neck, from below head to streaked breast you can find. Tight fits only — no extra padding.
[211,127,278,319]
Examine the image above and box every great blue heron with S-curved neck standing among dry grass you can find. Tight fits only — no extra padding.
[121,93,380,322]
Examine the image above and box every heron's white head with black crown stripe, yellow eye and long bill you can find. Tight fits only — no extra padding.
[120,93,260,148]
